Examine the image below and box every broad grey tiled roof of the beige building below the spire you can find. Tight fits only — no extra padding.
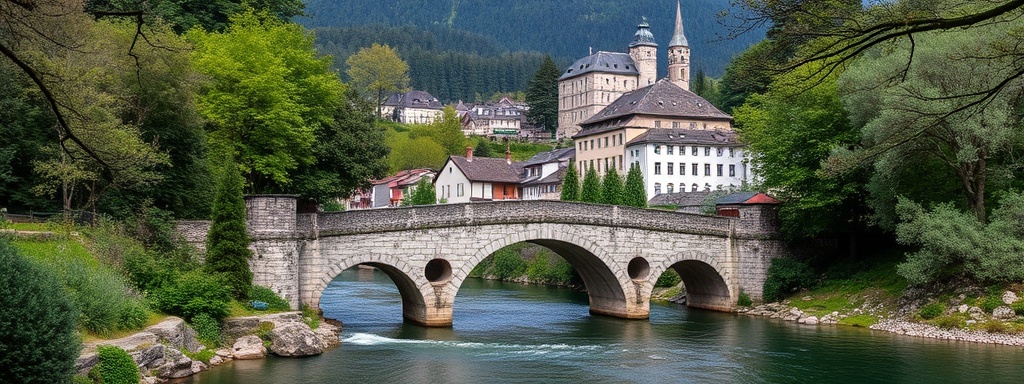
[581,79,732,128]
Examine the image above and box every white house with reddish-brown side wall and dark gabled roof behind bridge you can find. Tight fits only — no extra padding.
[434,147,522,203]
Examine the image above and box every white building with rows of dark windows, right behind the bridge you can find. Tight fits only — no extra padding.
[626,129,750,198]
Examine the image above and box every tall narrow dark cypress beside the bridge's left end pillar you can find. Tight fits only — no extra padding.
[206,162,253,299]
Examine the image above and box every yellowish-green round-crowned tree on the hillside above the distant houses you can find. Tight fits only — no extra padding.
[346,43,409,117]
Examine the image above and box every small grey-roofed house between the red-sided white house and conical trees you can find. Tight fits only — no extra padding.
[521,148,575,200]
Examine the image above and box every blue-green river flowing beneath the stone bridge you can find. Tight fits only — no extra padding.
[186,268,1024,384]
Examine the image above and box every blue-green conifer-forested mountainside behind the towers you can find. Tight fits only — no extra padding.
[298,0,764,100]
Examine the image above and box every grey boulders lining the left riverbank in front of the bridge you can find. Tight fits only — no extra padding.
[76,312,341,383]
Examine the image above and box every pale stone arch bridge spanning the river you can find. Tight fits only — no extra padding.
[190,196,784,327]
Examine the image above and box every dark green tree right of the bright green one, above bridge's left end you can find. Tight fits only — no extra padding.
[288,88,390,204]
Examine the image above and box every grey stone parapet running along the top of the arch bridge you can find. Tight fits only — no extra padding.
[311,201,748,237]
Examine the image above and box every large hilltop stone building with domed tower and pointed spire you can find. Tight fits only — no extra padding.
[556,1,690,138]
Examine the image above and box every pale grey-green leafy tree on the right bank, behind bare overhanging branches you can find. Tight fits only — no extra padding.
[828,20,1024,222]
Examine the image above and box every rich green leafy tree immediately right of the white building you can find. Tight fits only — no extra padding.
[734,68,865,239]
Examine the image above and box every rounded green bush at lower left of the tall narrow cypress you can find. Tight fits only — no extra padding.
[151,270,231,321]
